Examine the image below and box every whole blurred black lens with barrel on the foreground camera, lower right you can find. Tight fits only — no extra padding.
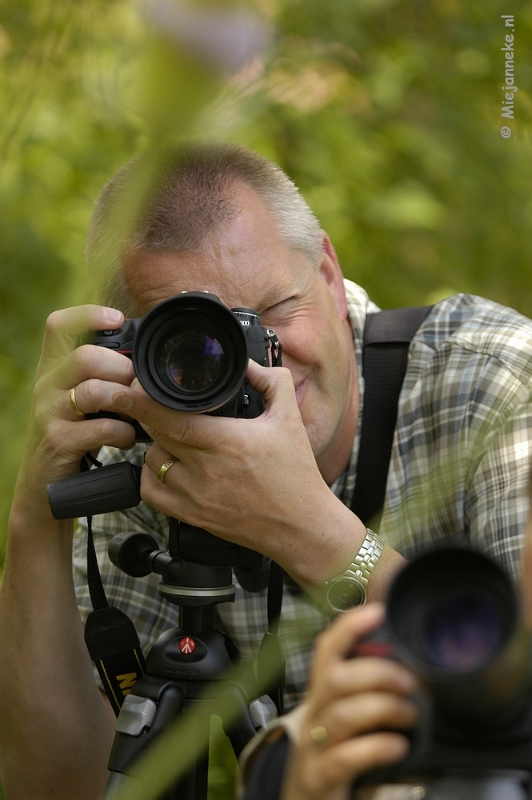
[386,547,532,737]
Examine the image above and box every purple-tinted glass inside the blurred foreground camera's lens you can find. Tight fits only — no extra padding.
[423,590,502,672]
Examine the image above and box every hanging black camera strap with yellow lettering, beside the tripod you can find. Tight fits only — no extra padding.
[81,454,144,716]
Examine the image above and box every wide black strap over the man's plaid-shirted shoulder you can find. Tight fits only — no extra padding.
[351,306,433,529]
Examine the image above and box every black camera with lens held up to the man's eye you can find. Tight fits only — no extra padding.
[91,292,279,418]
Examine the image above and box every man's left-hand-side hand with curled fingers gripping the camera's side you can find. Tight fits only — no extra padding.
[15,305,134,517]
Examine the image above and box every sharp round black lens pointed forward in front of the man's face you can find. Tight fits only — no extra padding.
[132,292,248,412]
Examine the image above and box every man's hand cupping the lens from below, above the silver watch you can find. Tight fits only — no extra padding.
[113,361,363,579]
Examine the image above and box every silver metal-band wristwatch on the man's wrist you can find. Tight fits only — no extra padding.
[320,528,384,615]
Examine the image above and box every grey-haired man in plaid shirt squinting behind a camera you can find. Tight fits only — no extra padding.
[0,141,532,800]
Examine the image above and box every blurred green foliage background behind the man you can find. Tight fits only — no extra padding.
[0,0,532,798]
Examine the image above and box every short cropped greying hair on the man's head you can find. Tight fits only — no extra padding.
[86,142,323,315]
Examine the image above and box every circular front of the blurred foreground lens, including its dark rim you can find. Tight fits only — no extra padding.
[388,548,515,675]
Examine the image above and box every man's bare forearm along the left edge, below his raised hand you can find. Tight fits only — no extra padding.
[0,508,112,800]
